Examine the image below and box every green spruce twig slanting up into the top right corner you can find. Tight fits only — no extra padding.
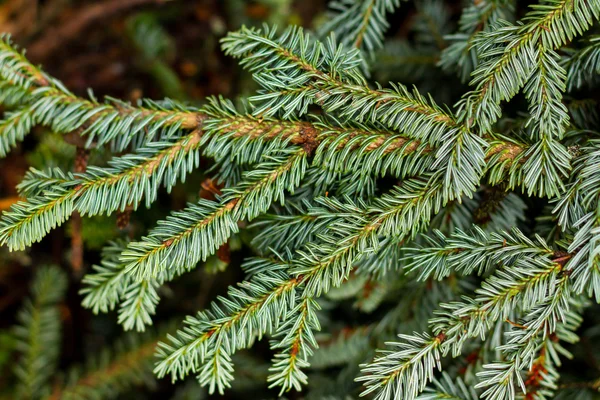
[458,0,600,132]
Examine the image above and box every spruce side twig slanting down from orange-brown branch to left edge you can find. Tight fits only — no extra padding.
[0,131,200,249]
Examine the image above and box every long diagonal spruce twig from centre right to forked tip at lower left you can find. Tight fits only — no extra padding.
[155,182,454,391]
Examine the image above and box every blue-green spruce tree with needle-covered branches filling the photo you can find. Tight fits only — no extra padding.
[0,0,600,400]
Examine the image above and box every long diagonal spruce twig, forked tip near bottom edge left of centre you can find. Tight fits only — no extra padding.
[156,180,450,391]
